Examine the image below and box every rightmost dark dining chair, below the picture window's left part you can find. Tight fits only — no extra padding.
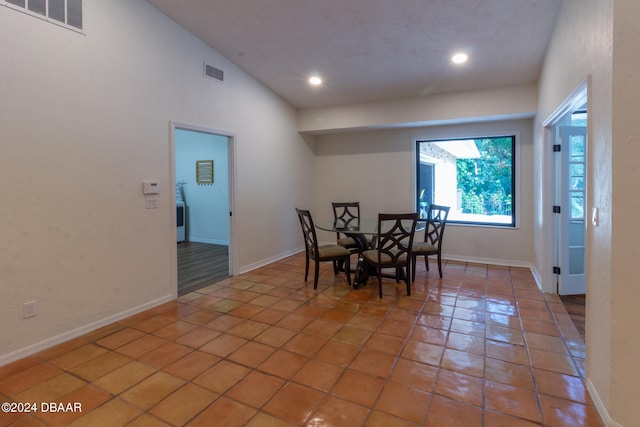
[411,204,450,280]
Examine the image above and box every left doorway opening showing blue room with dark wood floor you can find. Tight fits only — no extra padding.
[173,125,233,295]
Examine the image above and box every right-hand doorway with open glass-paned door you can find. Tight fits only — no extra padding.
[545,84,588,296]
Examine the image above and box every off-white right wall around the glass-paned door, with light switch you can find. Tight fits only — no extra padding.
[534,0,640,426]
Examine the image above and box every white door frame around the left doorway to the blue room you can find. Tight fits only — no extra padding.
[169,121,238,296]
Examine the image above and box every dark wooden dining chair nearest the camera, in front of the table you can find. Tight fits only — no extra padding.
[362,213,418,298]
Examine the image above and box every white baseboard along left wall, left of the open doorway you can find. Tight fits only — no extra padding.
[0,294,176,366]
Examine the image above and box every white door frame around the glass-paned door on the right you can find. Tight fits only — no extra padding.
[542,78,591,294]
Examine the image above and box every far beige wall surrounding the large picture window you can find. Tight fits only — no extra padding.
[314,120,535,266]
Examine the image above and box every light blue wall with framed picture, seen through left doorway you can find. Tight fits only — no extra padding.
[175,129,230,245]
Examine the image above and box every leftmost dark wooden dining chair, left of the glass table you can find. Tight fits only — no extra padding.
[296,208,351,289]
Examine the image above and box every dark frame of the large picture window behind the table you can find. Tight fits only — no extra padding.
[413,135,520,229]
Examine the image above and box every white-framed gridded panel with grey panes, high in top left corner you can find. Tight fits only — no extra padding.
[0,0,83,30]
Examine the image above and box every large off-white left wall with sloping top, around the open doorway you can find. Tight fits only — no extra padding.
[0,0,313,364]
